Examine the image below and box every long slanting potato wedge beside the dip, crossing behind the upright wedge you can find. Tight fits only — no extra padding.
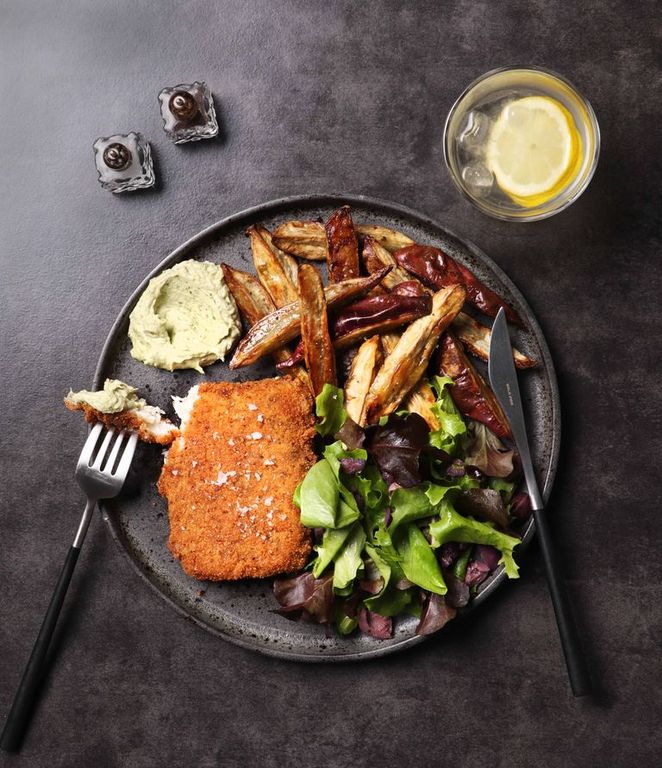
[230,265,389,368]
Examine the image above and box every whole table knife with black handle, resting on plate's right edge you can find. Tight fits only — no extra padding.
[488,309,591,696]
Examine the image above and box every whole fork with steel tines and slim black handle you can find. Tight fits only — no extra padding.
[0,424,138,752]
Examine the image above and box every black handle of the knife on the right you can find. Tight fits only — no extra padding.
[533,509,591,696]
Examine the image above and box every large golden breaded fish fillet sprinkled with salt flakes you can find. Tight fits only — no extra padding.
[158,378,315,581]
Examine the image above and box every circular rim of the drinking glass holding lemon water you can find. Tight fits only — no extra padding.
[443,64,600,224]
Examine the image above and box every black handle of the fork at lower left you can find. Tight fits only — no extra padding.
[0,547,80,752]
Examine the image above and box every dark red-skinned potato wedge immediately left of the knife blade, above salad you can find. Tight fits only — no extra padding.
[439,331,512,438]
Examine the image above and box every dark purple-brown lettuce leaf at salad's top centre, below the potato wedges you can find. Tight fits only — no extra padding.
[367,413,430,488]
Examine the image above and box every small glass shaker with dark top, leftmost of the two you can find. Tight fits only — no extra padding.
[93,132,155,193]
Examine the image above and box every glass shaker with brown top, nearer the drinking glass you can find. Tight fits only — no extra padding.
[159,81,218,144]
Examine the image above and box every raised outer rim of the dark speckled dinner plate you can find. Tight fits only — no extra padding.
[94,194,561,662]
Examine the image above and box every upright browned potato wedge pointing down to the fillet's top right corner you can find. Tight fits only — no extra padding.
[299,264,337,396]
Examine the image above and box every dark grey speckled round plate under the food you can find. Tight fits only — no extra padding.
[95,195,560,661]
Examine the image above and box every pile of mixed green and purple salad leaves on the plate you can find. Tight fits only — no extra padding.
[274,376,529,639]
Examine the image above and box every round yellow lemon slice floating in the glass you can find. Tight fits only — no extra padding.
[486,96,580,207]
